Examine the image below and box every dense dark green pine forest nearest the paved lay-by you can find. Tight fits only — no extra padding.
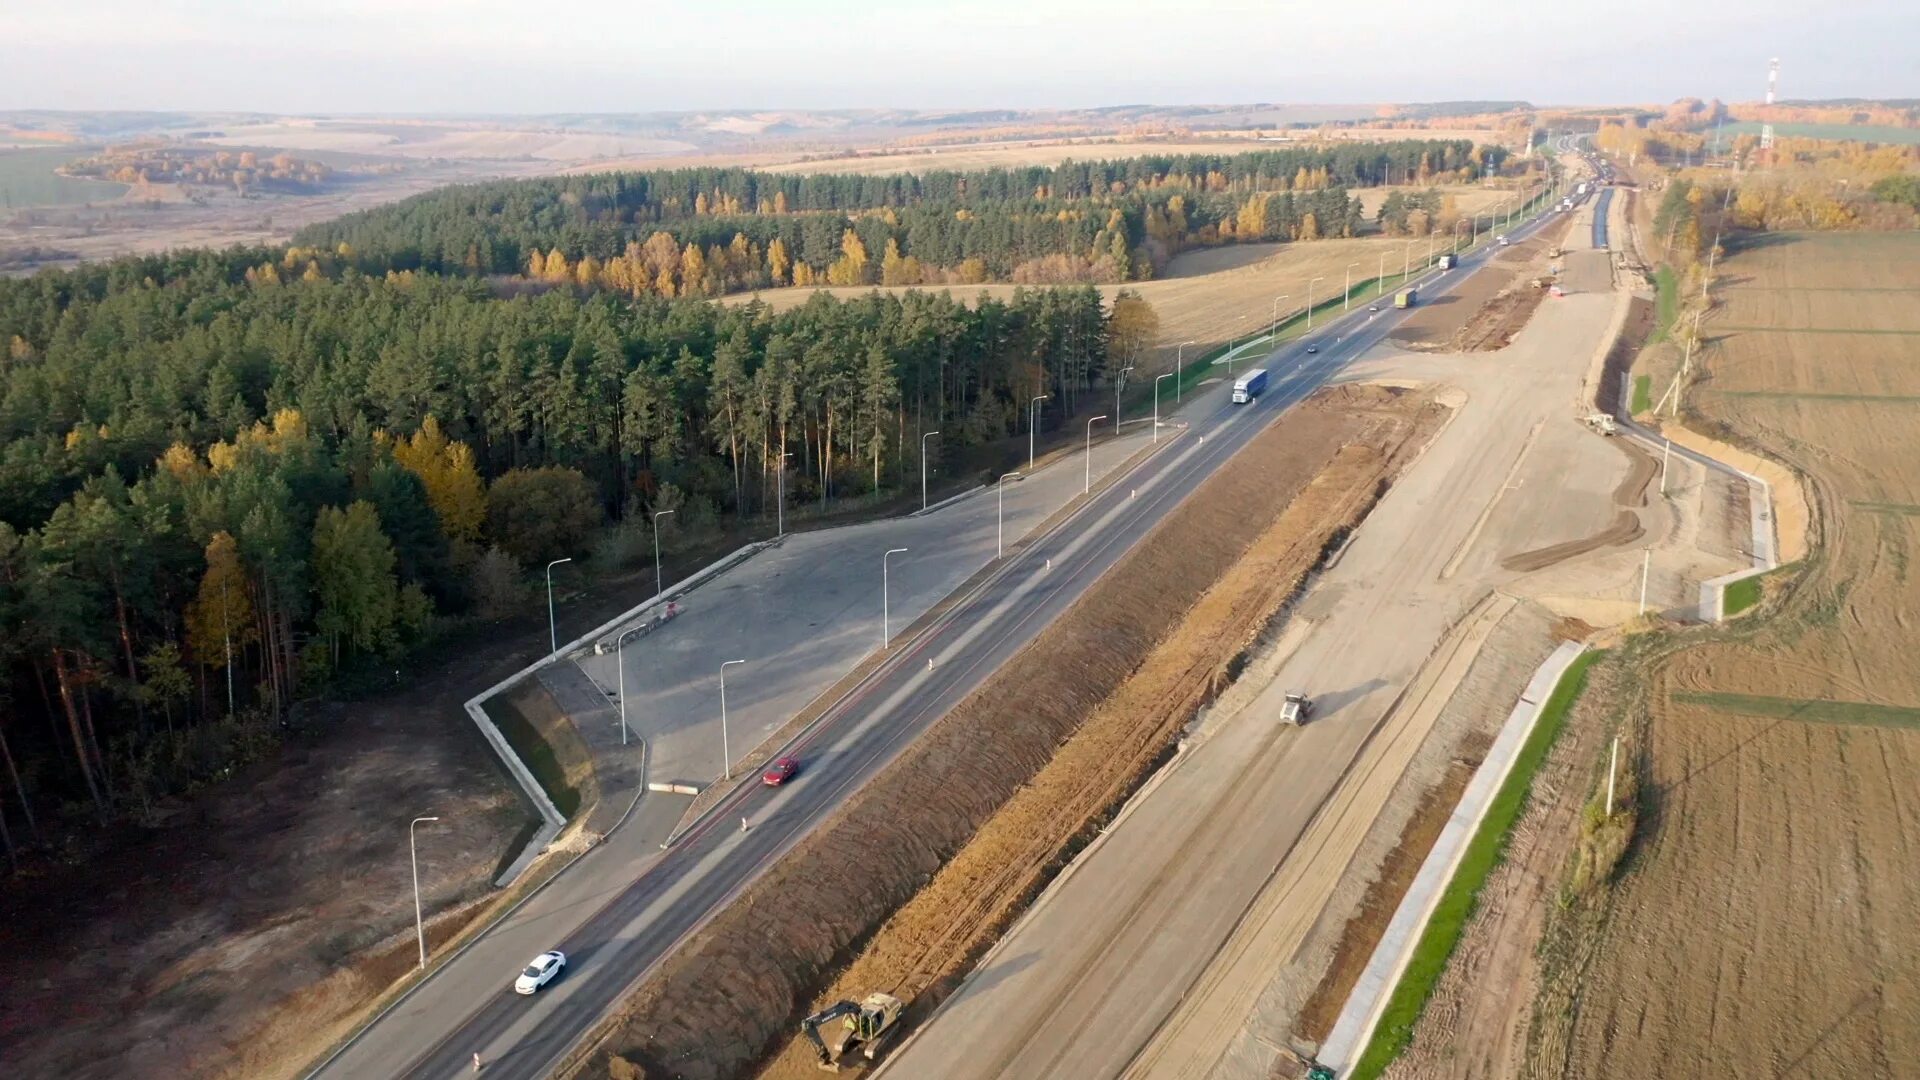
[0,248,1121,864]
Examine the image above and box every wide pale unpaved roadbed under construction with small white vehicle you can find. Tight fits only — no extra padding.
[883,201,1628,1080]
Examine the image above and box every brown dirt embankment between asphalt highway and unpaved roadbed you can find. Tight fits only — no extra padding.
[580,388,1443,1080]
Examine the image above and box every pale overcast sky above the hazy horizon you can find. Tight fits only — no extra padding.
[0,0,1920,113]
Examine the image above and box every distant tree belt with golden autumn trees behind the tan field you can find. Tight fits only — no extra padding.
[296,140,1505,296]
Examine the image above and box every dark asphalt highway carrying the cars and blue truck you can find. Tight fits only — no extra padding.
[315,191,1538,1080]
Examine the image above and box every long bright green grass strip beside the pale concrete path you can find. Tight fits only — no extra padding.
[1348,650,1605,1080]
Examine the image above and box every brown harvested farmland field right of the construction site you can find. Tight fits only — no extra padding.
[1538,233,1920,1078]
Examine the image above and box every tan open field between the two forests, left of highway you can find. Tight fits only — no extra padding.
[724,236,1459,379]
